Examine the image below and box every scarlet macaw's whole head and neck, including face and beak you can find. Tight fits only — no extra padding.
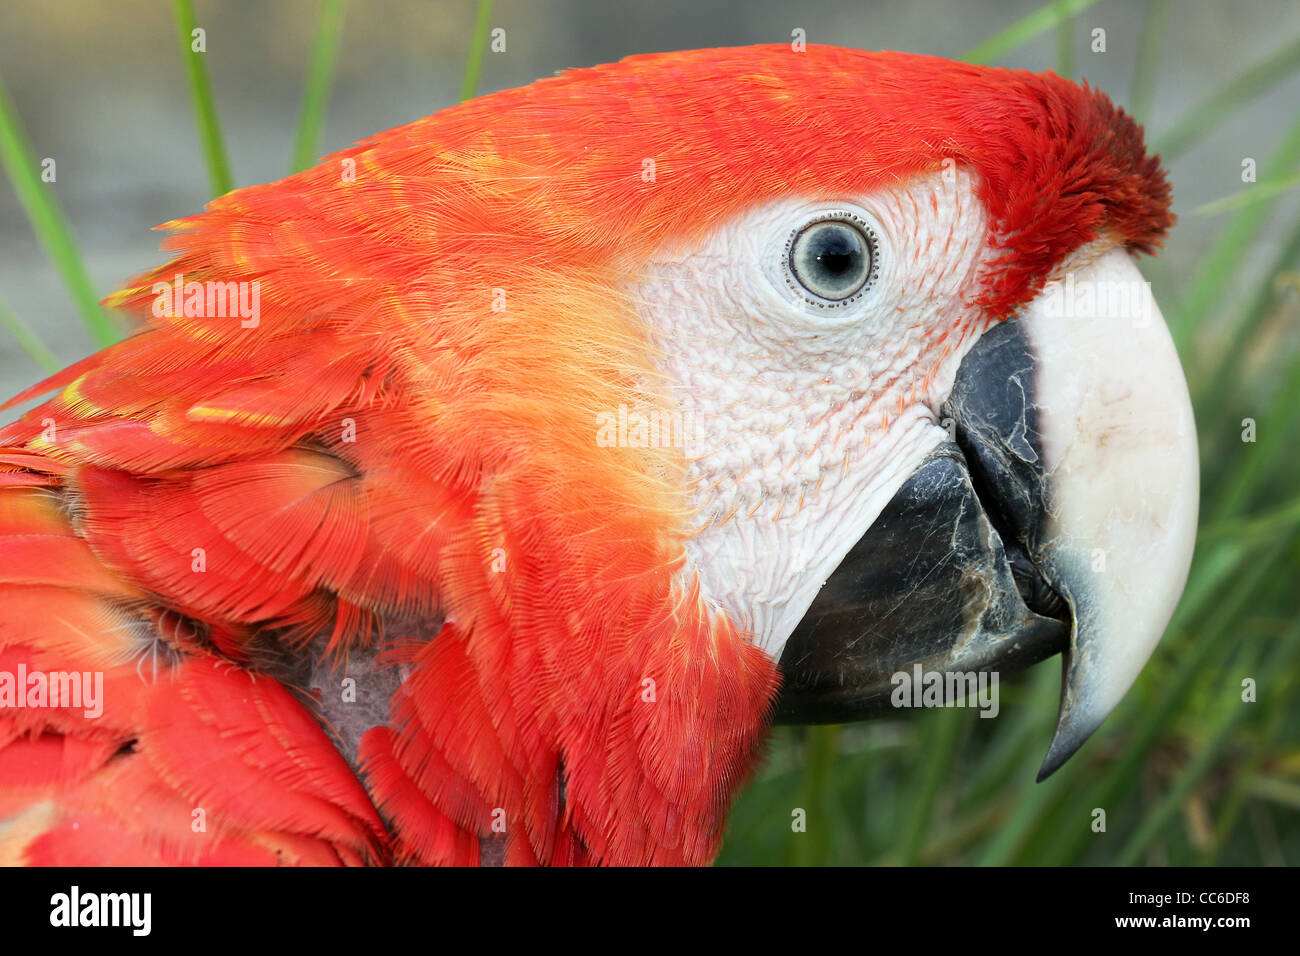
[58,46,1197,862]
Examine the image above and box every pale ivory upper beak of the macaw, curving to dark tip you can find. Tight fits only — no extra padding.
[1022,250,1200,779]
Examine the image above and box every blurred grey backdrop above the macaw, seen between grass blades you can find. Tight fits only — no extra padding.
[0,0,1300,395]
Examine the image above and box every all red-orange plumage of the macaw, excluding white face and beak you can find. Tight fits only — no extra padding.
[0,44,1171,864]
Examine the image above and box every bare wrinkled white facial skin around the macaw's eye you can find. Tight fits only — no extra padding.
[637,169,993,659]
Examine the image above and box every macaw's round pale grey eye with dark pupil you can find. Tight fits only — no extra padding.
[789,215,876,308]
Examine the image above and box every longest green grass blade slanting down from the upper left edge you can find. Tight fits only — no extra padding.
[0,71,118,348]
